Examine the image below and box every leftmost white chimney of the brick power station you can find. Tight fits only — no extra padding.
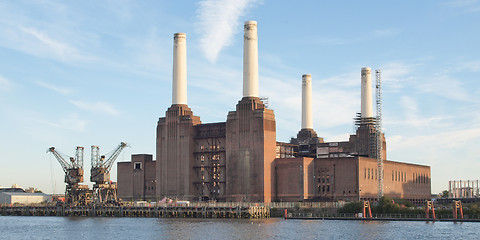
[172,33,187,105]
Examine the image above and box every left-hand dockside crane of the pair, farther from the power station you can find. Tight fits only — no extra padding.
[47,147,92,205]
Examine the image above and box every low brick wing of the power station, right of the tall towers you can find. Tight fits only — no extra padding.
[274,156,431,203]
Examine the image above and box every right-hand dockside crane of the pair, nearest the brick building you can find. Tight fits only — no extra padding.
[90,142,128,204]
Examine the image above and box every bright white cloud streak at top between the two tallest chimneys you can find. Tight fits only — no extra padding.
[197,0,258,62]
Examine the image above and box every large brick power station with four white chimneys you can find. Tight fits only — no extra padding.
[117,21,431,202]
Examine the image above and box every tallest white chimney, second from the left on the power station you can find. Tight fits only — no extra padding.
[243,21,258,97]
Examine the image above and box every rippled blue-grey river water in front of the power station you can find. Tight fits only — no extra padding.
[0,216,480,240]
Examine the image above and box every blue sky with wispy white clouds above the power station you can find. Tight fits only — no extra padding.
[0,0,480,193]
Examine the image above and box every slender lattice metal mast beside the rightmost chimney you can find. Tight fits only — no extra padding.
[375,69,384,200]
